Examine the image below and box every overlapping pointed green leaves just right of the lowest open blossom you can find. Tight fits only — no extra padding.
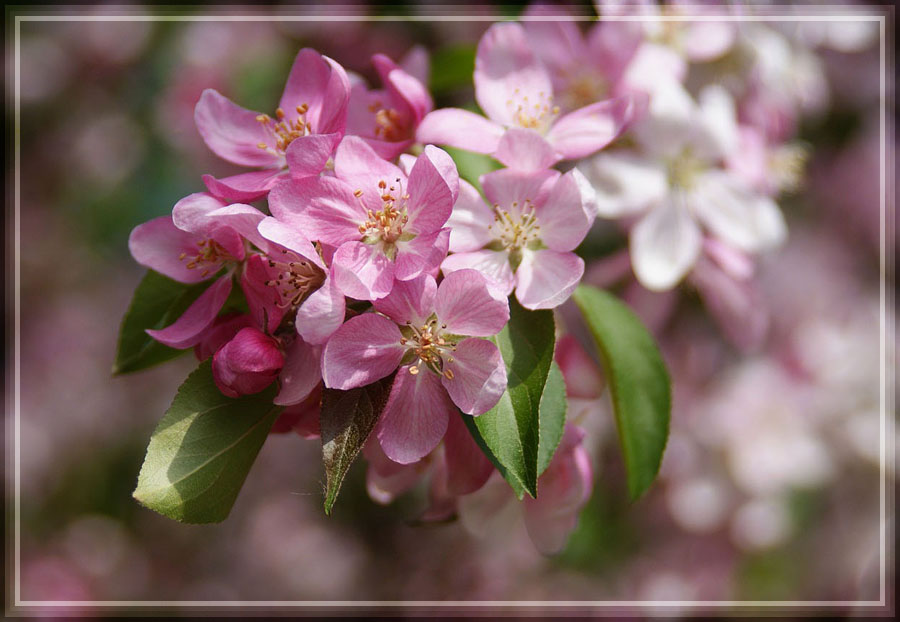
[466,298,566,498]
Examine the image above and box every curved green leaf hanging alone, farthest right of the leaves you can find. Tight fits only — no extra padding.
[574,285,672,500]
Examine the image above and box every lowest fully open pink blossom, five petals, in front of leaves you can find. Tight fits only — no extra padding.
[322,270,509,464]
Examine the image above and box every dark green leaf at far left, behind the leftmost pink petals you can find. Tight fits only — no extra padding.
[112,270,212,375]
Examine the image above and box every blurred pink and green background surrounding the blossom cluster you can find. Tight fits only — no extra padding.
[8,3,893,620]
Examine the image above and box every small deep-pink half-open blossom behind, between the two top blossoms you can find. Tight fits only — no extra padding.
[347,54,434,160]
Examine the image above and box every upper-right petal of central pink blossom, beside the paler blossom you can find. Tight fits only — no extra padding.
[407,145,459,233]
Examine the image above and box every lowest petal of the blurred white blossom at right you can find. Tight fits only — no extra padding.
[630,197,701,291]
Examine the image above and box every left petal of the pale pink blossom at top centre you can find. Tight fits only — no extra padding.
[416,108,503,153]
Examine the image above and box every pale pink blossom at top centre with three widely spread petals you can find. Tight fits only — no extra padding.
[416,23,643,169]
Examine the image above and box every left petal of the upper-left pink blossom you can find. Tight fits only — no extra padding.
[194,89,284,168]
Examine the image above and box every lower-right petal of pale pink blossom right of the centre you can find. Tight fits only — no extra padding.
[516,249,584,310]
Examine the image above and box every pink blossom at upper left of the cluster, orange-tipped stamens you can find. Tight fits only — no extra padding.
[194,48,350,201]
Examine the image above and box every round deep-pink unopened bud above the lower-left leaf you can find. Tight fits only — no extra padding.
[212,327,284,397]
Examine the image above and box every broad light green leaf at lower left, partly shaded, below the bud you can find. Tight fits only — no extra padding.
[134,360,281,523]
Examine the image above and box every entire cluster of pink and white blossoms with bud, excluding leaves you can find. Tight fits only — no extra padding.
[119,7,816,552]
